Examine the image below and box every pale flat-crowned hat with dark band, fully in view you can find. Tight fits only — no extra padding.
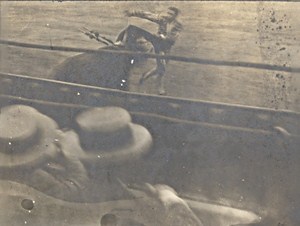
[66,107,152,163]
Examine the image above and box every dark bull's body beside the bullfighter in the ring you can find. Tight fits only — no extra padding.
[52,46,142,91]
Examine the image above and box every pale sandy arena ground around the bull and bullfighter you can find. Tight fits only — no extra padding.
[0,1,300,111]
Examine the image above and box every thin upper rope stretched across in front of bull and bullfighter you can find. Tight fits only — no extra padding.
[0,40,300,73]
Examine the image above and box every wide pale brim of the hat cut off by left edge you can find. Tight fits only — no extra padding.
[0,105,58,169]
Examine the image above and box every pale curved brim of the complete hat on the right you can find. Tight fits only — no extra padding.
[66,123,152,165]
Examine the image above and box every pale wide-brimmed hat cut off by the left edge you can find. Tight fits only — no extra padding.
[0,105,58,169]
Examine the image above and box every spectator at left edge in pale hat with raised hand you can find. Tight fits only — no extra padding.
[0,105,88,201]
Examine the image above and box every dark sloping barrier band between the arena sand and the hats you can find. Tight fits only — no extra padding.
[0,73,300,135]
